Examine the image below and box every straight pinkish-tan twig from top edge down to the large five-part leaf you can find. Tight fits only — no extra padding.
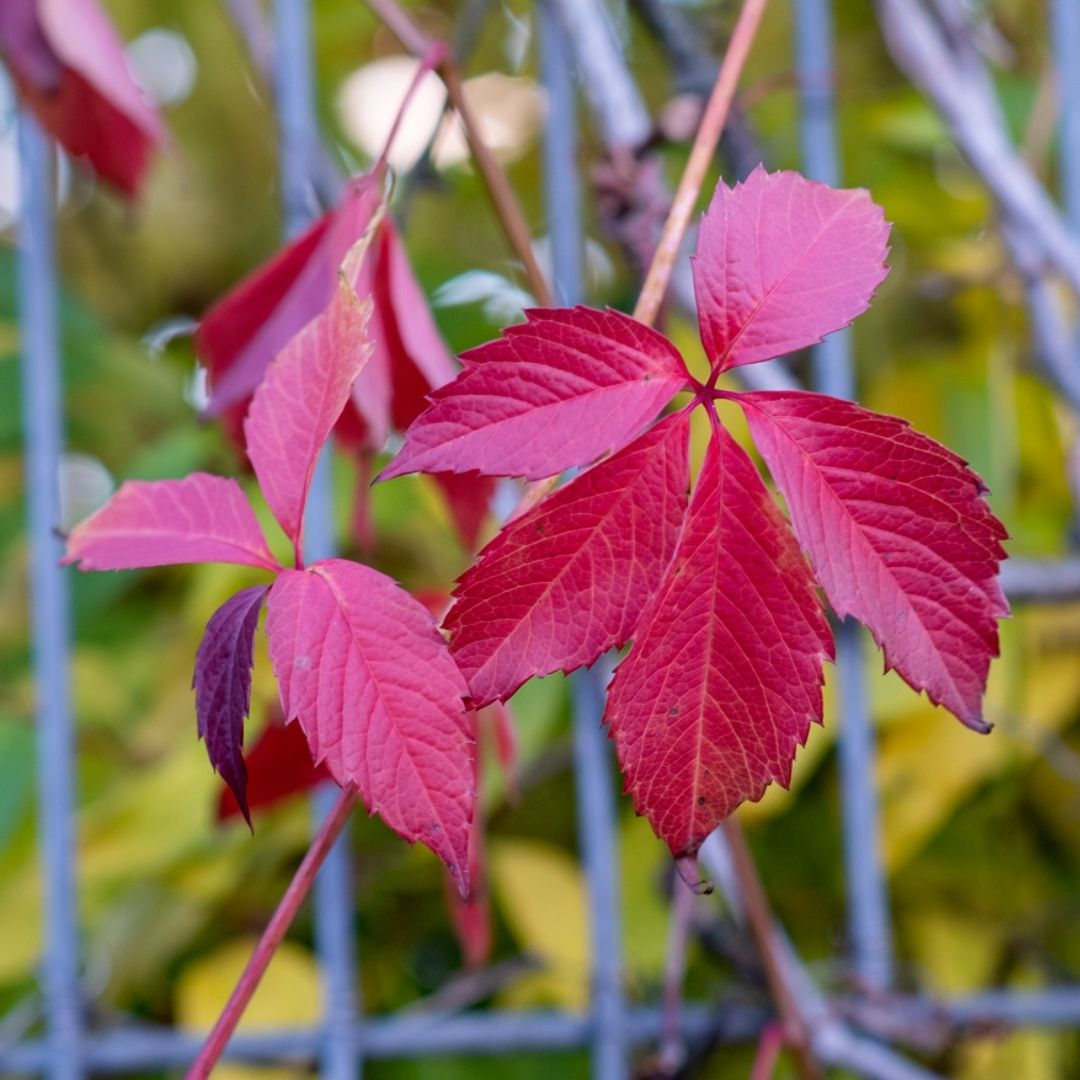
[634,0,768,324]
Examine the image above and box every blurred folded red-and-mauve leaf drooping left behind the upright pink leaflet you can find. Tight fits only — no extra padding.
[195,177,382,416]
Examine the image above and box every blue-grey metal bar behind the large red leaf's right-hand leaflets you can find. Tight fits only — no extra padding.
[793,0,894,987]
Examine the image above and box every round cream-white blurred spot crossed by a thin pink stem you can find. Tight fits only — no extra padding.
[337,56,446,173]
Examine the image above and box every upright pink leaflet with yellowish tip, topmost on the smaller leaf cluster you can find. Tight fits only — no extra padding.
[244,281,370,562]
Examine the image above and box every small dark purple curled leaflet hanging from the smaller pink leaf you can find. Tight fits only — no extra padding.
[191,585,268,825]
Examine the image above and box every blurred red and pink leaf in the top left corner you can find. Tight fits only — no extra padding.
[0,0,165,195]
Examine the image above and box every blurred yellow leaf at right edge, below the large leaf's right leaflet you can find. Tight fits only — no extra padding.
[877,604,1080,870]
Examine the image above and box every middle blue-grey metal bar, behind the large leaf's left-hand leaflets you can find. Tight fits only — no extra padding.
[537,10,629,1080]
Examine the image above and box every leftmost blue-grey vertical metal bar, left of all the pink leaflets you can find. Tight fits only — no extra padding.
[17,113,82,1080]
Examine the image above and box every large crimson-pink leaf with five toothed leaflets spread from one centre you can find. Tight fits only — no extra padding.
[382,168,1007,880]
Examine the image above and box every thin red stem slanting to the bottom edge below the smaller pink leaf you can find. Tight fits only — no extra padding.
[186,785,356,1080]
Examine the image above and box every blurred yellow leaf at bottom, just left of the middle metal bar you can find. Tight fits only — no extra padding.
[490,840,589,1012]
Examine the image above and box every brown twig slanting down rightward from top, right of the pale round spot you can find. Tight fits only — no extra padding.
[366,0,555,308]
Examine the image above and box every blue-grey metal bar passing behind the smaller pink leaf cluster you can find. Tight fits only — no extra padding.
[274,0,361,1080]
